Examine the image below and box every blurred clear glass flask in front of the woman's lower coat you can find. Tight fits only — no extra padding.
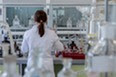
[24,48,52,77]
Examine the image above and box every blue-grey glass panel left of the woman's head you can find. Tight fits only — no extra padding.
[6,7,43,29]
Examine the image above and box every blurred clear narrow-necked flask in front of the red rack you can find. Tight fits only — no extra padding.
[58,59,77,77]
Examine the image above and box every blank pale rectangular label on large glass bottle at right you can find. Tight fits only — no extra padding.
[89,56,116,72]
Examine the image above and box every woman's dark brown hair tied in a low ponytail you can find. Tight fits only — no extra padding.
[34,10,47,37]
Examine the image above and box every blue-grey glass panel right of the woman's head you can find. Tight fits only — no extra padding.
[53,6,90,27]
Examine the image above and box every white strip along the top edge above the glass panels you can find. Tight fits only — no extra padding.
[0,0,116,4]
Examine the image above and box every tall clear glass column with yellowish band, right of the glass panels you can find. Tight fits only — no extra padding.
[88,0,100,46]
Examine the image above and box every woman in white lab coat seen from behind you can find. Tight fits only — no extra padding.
[21,10,64,77]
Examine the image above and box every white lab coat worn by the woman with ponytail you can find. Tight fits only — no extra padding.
[21,25,64,77]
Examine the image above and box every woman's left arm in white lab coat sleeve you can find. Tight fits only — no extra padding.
[21,33,29,54]
